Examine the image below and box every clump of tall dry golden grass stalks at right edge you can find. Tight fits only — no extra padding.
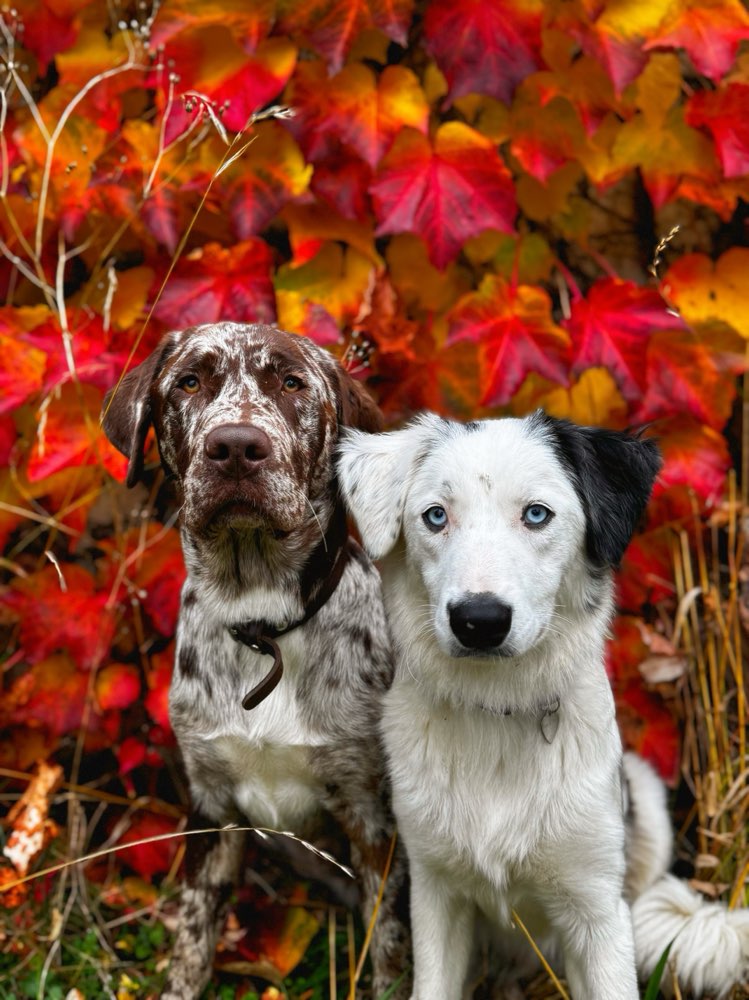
[674,464,749,907]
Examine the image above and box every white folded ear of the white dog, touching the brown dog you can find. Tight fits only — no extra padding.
[337,414,443,559]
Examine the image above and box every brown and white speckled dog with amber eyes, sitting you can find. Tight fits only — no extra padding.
[103,323,409,1000]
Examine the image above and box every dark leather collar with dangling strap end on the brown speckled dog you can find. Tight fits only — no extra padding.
[227,536,356,711]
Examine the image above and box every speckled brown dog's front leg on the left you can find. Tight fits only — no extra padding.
[161,813,246,1000]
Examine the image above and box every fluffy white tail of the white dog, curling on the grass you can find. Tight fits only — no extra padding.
[624,754,749,998]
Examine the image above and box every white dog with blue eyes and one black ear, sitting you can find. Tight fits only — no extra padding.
[339,412,749,1000]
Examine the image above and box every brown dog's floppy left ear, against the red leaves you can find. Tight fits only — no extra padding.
[101,333,179,487]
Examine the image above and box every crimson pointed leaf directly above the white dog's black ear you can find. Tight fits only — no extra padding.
[563,278,684,401]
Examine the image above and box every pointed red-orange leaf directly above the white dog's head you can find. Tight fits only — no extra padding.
[448,275,569,406]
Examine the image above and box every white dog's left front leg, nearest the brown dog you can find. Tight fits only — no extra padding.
[411,858,475,1000]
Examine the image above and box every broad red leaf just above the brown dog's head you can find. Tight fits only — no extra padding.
[154,239,276,328]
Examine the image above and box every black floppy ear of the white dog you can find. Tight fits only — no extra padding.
[534,412,662,566]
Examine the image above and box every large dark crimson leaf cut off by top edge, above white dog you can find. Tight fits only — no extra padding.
[424,0,541,104]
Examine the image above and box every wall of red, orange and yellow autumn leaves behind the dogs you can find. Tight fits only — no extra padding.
[0,0,749,996]
